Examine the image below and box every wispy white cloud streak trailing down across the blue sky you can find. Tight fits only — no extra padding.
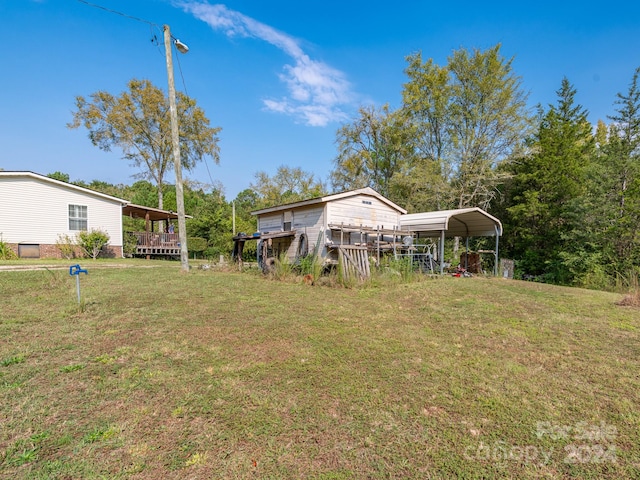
[180,2,352,127]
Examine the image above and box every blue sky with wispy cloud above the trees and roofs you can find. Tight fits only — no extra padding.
[0,0,640,200]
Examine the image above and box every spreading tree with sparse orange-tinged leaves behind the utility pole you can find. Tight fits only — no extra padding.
[67,79,220,208]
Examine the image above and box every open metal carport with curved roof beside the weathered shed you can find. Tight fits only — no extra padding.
[400,207,502,275]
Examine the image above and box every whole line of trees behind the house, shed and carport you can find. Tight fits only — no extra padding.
[61,45,640,288]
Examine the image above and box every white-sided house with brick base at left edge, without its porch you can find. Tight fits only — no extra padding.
[0,171,128,258]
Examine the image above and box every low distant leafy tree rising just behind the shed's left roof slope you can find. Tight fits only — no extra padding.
[250,165,326,207]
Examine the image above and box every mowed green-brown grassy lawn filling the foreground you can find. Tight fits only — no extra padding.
[0,261,640,479]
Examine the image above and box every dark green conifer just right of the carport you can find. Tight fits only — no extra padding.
[505,78,597,283]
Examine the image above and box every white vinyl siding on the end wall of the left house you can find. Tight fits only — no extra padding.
[0,174,122,246]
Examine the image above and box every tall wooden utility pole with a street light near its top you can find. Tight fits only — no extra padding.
[163,25,189,272]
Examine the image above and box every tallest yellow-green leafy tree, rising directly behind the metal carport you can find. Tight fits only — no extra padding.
[403,45,530,208]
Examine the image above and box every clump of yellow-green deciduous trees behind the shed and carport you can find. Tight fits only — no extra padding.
[331,45,531,211]
